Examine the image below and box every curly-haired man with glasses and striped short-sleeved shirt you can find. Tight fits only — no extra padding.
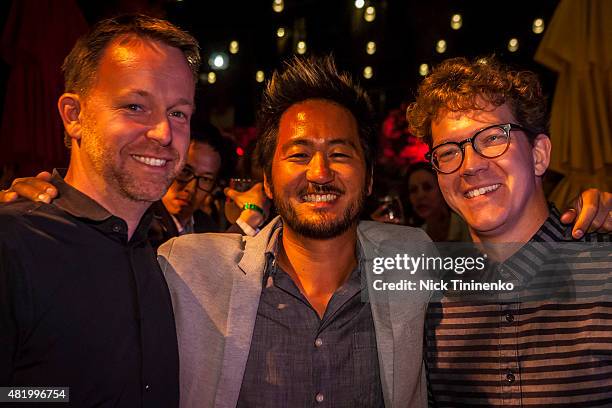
[407,58,612,407]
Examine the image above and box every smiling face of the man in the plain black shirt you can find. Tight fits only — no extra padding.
[75,37,194,201]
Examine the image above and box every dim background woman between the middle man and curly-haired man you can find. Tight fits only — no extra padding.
[407,162,470,242]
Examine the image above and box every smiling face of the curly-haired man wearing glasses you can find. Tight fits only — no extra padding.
[432,104,548,241]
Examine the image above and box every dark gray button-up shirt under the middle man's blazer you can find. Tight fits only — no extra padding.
[238,229,384,407]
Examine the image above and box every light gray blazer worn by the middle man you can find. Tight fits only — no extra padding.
[158,218,430,408]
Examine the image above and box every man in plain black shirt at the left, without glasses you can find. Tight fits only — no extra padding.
[0,15,200,408]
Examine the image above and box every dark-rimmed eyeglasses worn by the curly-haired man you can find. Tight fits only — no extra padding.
[425,123,531,174]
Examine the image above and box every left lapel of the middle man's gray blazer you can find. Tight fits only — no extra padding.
[215,219,279,408]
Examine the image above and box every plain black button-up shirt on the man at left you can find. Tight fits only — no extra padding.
[0,172,178,408]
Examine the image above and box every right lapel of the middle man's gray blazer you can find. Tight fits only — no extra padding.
[358,230,395,407]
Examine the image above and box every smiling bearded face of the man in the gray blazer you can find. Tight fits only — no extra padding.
[265,99,370,239]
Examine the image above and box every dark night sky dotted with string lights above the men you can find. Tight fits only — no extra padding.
[74,0,558,126]
